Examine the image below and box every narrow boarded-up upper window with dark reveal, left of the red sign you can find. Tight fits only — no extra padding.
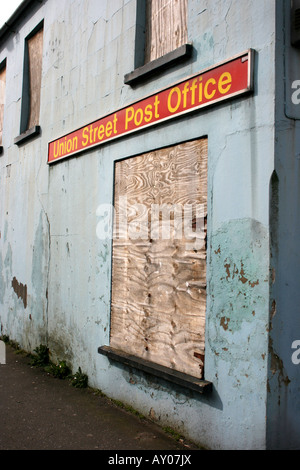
[21,27,43,132]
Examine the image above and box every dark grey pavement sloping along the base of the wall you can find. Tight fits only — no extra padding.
[0,346,197,452]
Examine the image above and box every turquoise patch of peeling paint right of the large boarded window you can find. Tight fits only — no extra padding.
[207,219,269,373]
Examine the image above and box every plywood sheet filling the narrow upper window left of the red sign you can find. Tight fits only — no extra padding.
[28,29,43,129]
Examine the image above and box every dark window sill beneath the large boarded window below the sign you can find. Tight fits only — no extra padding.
[98,346,212,394]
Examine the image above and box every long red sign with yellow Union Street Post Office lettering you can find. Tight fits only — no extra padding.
[48,50,253,163]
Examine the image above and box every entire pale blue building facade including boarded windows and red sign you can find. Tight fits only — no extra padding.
[0,0,300,449]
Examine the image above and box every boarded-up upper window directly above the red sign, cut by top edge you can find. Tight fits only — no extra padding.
[145,0,187,63]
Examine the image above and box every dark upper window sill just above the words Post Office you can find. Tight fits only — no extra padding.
[124,44,193,85]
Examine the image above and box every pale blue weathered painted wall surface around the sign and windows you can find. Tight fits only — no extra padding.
[0,0,284,449]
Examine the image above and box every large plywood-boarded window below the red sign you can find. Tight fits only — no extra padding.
[110,139,207,378]
